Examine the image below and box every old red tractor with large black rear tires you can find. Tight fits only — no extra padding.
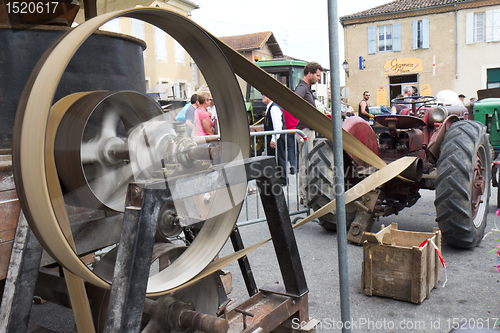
[307,96,491,248]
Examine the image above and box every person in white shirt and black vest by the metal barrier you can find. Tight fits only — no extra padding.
[262,95,286,186]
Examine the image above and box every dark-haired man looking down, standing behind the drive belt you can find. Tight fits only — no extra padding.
[295,62,324,204]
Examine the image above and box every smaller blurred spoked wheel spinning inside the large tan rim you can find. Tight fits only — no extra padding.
[55,91,164,212]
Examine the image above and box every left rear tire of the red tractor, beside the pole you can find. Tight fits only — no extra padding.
[306,139,356,231]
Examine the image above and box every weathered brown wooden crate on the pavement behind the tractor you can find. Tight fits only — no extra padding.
[361,223,441,303]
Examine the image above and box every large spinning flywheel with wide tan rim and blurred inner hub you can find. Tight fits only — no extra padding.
[13,8,249,295]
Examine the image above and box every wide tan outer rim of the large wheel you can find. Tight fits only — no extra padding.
[13,8,249,293]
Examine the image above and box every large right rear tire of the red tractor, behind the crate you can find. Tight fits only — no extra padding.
[434,120,491,248]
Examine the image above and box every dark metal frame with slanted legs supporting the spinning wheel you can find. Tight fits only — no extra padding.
[0,157,309,332]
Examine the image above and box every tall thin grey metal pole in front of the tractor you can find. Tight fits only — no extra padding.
[328,0,351,333]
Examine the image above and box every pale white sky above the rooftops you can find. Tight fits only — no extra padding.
[191,0,391,84]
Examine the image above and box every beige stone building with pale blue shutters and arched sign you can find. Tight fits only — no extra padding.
[340,0,500,106]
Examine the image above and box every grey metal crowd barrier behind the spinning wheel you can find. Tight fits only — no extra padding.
[236,130,312,226]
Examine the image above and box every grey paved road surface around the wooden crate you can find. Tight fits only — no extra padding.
[27,179,500,333]
